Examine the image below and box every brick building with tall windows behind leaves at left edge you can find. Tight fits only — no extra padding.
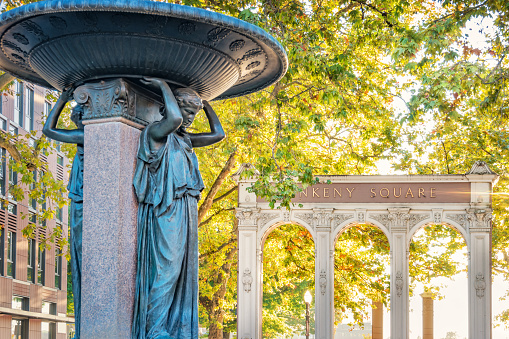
[0,81,73,339]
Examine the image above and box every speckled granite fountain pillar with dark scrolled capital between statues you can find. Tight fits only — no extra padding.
[78,79,159,339]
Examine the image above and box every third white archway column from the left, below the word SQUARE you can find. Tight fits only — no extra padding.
[388,208,410,339]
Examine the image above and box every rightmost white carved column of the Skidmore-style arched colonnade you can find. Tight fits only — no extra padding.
[467,209,491,338]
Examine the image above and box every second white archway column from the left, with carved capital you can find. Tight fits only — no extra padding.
[314,209,334,339]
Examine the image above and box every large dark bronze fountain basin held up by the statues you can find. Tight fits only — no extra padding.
[0,0,288,100]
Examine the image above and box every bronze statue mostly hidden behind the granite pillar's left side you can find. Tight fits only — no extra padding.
[42,88,85,339]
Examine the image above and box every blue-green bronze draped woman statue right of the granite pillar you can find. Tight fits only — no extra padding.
[132,78,225,339]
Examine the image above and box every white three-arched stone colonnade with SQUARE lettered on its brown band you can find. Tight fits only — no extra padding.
[234,162,498,339]
